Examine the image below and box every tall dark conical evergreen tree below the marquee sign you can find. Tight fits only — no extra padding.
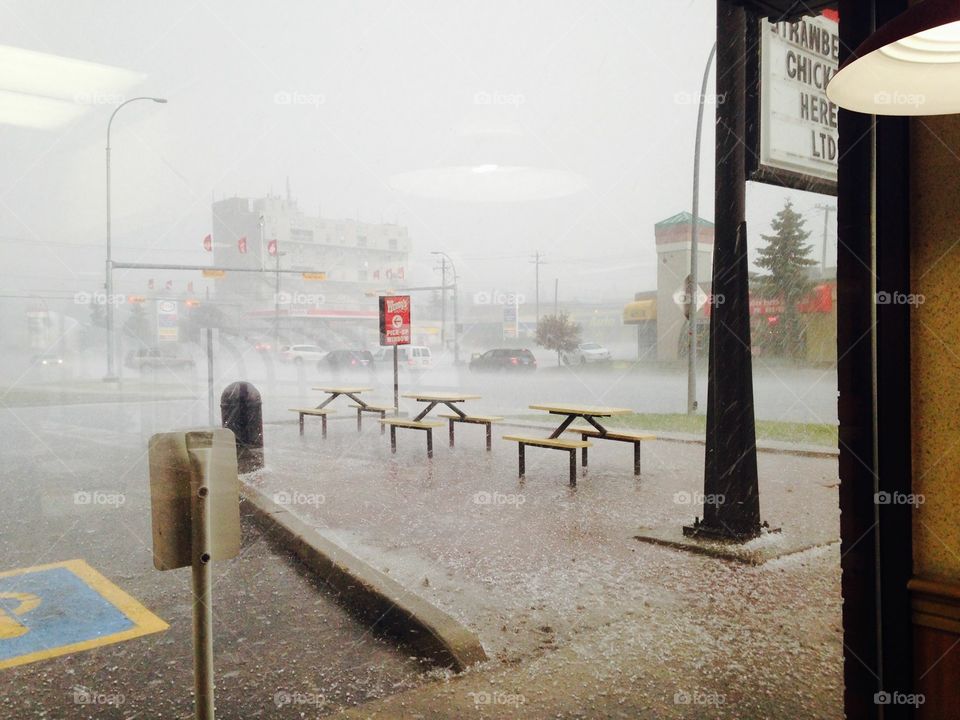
[757,200,817,358]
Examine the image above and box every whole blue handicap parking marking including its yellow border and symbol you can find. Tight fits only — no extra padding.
[0,560,168,669]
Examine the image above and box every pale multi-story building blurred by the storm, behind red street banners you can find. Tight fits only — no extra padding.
[213,196,410,346]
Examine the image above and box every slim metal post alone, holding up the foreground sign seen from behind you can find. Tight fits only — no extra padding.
[191,464,214,720]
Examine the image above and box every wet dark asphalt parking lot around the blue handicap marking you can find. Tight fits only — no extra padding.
[0,403,431,720]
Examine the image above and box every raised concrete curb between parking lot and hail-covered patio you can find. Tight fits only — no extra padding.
[233,481,488,672]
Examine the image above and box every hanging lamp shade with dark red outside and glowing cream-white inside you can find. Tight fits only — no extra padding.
[827,0,960,115]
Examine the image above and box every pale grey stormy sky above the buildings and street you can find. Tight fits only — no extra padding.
[0,0,835,300]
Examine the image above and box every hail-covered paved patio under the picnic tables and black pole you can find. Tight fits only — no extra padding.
[249,423,842,718]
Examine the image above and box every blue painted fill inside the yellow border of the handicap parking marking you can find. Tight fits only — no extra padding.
[0,567,134,660]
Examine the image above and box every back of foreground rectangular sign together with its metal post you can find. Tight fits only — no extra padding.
[149,428,240,720]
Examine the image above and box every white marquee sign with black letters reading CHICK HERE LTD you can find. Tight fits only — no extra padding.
[747,15,840,195]
